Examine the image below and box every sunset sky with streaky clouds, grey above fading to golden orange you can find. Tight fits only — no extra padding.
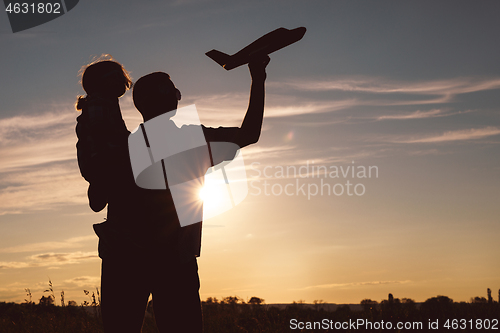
[0,0,500,304]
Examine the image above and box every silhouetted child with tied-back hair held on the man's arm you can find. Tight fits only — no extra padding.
[76,55,132,212]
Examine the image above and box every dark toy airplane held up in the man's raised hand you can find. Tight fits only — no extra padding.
[205,27,306,70]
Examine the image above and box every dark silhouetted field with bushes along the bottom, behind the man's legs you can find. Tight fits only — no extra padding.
[0,295,500,333]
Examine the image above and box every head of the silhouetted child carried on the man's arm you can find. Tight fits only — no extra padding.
[82,55,132,97]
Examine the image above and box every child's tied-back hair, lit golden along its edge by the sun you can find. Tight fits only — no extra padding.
[75,54,132,110]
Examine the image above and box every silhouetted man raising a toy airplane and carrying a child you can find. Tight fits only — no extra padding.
[94,56,269,332]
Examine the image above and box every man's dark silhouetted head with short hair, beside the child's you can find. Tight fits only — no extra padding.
[133,72,181,121]
